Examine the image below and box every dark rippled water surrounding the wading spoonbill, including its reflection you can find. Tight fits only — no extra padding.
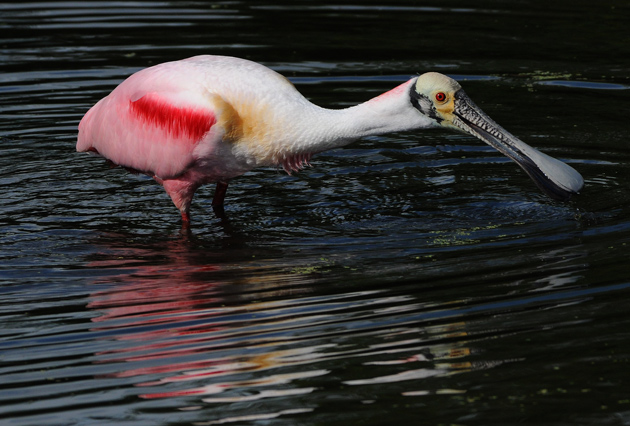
[0,1,630,425]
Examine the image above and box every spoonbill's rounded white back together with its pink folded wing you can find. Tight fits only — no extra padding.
[77,56,303,179]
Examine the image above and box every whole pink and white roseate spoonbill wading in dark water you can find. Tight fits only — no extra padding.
[76,55,584,223]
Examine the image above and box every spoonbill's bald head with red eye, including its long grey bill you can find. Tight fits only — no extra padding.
[410,72,584,201]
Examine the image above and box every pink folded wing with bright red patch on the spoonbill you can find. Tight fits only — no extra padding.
[77,68,222,179]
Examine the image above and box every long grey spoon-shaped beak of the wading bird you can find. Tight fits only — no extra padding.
[443,89,584,201]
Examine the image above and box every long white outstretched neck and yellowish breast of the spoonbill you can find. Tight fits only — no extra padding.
[234,78,434,171]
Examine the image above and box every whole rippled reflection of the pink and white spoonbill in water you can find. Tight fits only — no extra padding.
[82,231,478,403]
